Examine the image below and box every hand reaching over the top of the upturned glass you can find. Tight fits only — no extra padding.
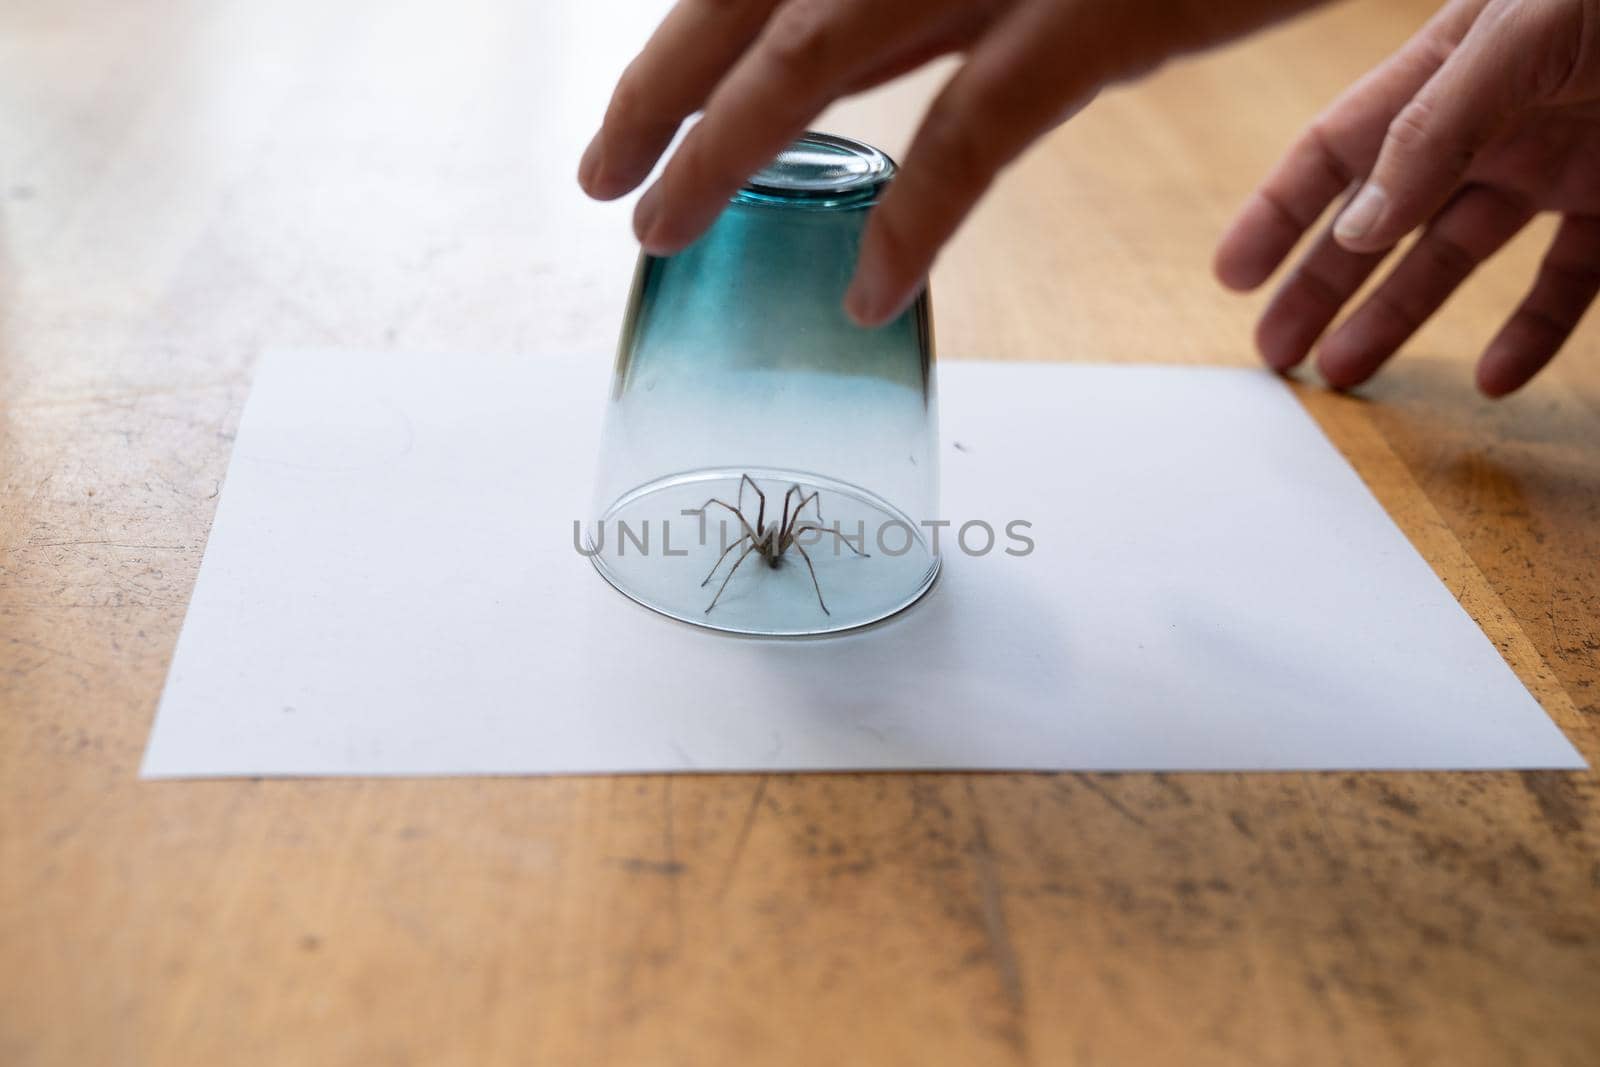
[579,0,1315,325]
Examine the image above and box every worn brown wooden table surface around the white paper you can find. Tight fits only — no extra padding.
[0,0,1600,1065]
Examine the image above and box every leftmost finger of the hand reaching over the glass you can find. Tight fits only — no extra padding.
[578,0,778,200]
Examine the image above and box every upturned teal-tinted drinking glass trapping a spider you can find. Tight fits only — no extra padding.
[586,133,939,635]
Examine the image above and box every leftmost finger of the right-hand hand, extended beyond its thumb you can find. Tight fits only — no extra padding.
[1213,0,1483,290]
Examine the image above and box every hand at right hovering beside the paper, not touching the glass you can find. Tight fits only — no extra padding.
[1216,0,1600,397]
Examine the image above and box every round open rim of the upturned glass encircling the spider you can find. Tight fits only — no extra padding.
[586,469,939,637]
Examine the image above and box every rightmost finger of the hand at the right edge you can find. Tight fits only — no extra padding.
[1478,214,1600,397]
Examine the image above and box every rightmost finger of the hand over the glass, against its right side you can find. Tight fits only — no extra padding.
[845,3,1107,326]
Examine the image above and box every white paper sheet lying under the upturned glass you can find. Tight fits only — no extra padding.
[144,352,1584,777]
